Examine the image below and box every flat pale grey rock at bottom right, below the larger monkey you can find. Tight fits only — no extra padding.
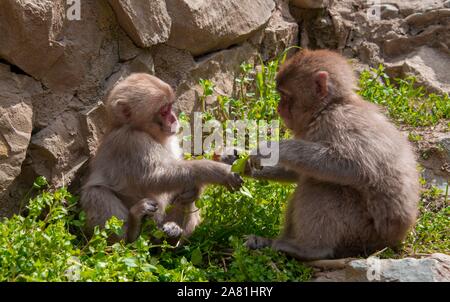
[313,254,450,282]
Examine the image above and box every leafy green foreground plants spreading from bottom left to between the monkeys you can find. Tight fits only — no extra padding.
[0,178,311,281]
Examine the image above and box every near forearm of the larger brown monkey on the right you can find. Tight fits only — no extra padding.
[279,140,367,185]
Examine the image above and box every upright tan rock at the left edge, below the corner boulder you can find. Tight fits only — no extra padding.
[0,64,42,195]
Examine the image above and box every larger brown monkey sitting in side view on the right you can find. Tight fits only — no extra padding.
[243,50,419,260]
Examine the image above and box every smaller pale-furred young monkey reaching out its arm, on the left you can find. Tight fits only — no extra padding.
[81,74,242,242]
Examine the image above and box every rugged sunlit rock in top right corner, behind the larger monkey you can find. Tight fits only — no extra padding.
[291,0,450,93]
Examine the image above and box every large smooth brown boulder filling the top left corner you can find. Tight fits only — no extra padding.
[0,0,118,92]
